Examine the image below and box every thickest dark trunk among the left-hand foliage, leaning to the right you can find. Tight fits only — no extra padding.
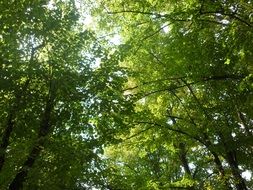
[9,80,55,190]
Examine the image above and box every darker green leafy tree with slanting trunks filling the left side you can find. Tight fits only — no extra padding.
[0,1,130,190]
